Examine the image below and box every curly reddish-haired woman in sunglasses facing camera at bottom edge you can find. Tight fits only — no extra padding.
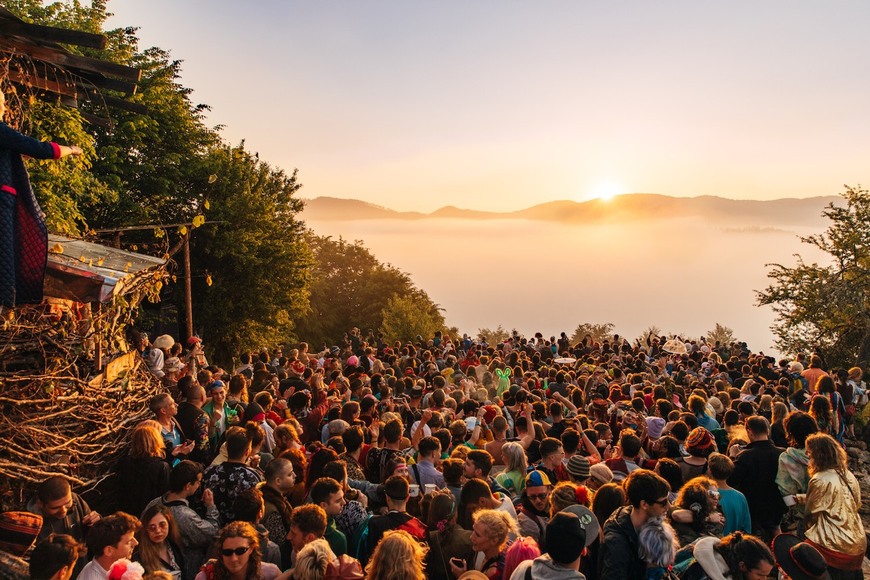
[194,522,281,580]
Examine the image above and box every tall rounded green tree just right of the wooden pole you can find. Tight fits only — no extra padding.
[191,146,311,360]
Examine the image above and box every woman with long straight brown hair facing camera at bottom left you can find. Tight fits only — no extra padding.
[133,503,184,578]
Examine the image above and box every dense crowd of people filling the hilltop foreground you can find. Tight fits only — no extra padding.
[0,329,867,580]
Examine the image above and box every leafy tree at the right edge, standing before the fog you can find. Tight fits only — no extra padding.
[756,186,870,366]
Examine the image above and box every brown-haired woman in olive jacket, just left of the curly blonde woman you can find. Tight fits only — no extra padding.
[426,490,472,580]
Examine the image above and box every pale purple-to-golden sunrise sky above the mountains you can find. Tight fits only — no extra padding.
[108,0,870,212]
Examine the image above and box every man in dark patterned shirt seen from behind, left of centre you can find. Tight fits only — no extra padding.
[203,427,263,525]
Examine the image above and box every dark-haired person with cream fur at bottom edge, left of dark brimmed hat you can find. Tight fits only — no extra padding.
[681,532,775,580]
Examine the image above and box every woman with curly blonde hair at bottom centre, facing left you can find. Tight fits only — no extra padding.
[450,509,518,580]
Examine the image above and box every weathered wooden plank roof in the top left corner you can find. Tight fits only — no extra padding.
[0,5,148,125]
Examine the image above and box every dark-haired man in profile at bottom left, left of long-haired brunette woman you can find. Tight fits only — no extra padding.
[77,512,141,580]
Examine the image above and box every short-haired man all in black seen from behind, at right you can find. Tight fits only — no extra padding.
[728,415,785,543]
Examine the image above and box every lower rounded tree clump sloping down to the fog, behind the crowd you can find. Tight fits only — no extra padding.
[297,232,443,345]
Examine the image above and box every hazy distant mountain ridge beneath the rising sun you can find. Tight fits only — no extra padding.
[302,193,842,227]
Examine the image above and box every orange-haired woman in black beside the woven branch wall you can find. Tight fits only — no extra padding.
[118,420,170,514]
